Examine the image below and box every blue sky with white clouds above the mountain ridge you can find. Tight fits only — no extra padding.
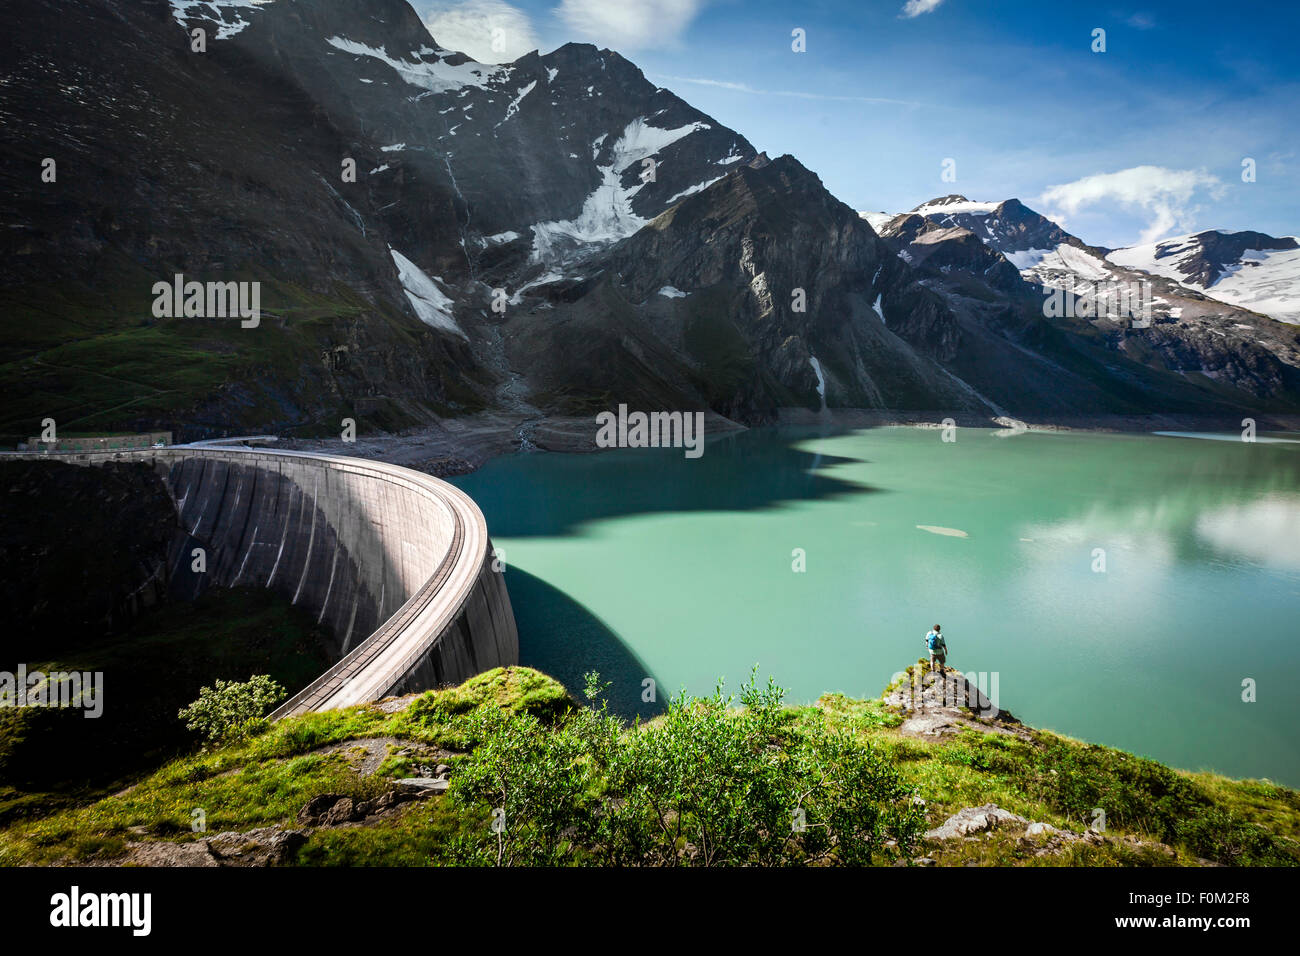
[413,0,1300,246]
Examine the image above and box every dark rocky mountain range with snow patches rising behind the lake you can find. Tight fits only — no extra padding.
[0,0,1300,436]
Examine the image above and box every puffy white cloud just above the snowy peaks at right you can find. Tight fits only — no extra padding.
[1039,166,1225,242]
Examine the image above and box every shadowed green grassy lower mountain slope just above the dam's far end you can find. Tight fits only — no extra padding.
[0,269,481,444]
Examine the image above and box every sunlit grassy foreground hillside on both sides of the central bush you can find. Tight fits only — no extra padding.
[0,667,1300,865]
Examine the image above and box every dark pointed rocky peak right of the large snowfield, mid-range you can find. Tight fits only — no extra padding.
[598,156,987,421]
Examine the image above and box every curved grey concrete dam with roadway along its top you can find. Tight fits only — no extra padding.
[13,446,519,719]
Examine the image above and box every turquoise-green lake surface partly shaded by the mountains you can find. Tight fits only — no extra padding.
[456,428,1300,787]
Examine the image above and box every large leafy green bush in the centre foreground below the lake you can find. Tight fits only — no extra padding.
[450,675,923,866]
